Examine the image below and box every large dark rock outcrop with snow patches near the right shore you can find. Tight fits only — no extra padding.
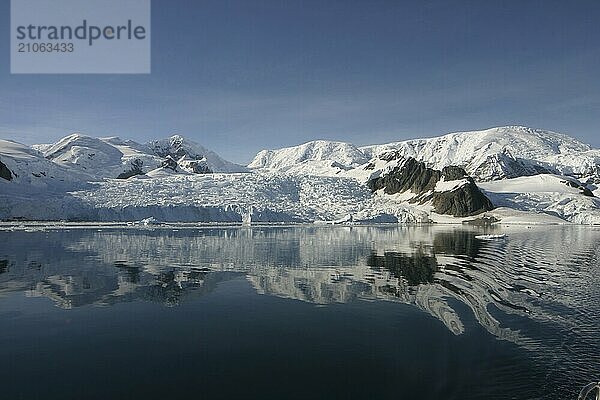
[367,157,494,217]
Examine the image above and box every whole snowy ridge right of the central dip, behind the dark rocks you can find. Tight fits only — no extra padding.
[249,126,600,182]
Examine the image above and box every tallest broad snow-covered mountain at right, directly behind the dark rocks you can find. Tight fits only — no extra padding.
[360,126,600,181]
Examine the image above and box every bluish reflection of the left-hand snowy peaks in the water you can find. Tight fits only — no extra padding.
[0,231,244,308]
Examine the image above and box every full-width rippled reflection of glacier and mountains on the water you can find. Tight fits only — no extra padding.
[0,226,600,390]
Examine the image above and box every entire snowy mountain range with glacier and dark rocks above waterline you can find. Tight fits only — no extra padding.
[0,126,600,224]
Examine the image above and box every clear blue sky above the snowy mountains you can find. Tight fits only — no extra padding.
[0,0,600,163]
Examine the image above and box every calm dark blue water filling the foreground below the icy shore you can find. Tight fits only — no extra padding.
[0,227,600,399]
